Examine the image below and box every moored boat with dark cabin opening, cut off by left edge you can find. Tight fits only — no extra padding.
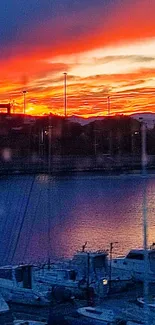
[0,265,49,306]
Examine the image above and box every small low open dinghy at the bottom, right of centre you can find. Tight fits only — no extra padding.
[77,307,126,325]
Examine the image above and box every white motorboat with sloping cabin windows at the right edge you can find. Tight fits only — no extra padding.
[111,249,155,282]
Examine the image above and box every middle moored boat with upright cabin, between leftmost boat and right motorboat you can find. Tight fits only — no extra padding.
[34,251,108,297]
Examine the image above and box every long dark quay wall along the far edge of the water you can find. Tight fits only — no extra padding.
[0,155,155,175]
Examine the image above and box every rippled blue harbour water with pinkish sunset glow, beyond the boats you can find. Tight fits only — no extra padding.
[0,174,155,264]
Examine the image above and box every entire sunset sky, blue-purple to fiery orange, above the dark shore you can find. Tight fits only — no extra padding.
[0,0,155,117]
